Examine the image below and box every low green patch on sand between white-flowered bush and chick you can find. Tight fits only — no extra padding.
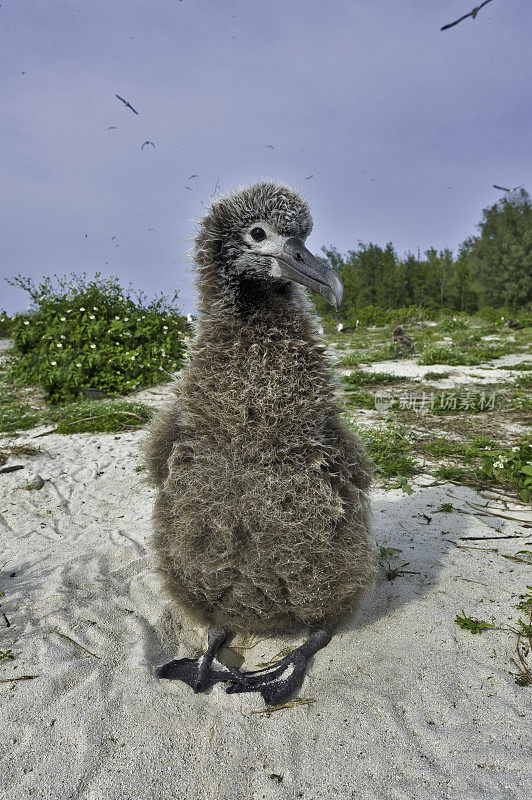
[47,400,153,434]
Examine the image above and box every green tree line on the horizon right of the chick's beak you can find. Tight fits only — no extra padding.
[315,189,532,320]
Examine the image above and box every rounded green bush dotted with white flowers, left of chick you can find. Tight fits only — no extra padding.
[9,273,187,403]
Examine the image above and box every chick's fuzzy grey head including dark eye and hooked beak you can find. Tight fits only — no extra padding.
[195,182,344,309]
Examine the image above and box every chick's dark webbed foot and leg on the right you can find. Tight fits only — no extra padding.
[226,627,331,706]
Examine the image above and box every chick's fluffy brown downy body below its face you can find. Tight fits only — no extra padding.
[147,184,375,632]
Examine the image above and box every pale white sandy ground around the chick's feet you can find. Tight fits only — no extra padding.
[0,376,532,800]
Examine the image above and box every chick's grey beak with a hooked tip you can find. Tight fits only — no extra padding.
[271,236,344,311]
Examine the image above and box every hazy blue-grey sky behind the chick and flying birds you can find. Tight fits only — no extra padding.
[0,0,532,312]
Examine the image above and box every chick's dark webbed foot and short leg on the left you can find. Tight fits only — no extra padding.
[155,626,241,692]
